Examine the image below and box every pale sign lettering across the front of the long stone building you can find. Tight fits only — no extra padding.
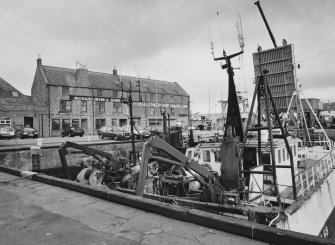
[70,96,188,109]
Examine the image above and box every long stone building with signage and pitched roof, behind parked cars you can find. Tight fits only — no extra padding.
[31,58,190,137]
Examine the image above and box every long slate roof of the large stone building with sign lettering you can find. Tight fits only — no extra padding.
[41,65,188,96]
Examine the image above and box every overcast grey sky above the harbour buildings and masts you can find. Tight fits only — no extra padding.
[0,0,335,113]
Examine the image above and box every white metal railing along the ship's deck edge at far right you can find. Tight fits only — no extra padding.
[296,148,335,197]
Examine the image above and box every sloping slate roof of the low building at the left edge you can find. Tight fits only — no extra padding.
[0,77,33,106]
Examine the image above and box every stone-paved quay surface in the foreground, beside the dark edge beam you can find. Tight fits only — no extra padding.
[0,172,268,245]
